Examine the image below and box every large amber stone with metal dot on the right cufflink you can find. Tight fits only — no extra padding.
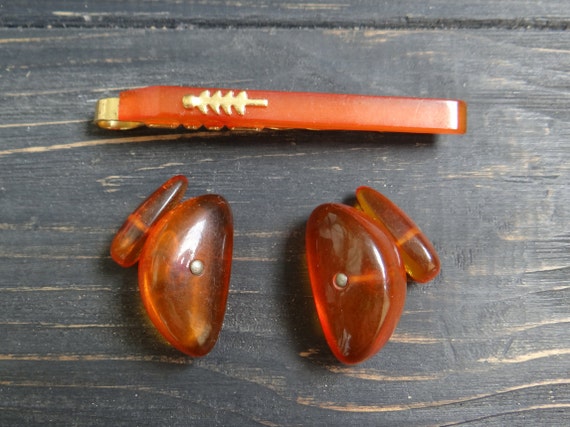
[306,203,406,364]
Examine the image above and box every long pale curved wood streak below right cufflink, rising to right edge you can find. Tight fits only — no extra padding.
[297,378,570,412]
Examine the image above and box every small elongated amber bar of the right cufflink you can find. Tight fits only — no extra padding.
[356,187,440,283]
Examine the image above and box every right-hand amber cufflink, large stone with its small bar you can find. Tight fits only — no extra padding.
[305,187,439,364]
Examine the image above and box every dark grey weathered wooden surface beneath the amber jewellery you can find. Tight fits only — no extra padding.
[0,0,570,426]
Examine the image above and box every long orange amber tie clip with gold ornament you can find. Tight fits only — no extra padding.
[95,86,467,134]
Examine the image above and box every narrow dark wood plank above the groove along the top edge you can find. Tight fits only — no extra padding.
[0,0,570,30]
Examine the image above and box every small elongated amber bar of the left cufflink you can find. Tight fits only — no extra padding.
[107,175,188,267]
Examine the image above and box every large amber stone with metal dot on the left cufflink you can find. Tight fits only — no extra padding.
[139,195,233,357]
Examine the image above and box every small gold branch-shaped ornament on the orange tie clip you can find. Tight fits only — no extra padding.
[182,90,269,116]
